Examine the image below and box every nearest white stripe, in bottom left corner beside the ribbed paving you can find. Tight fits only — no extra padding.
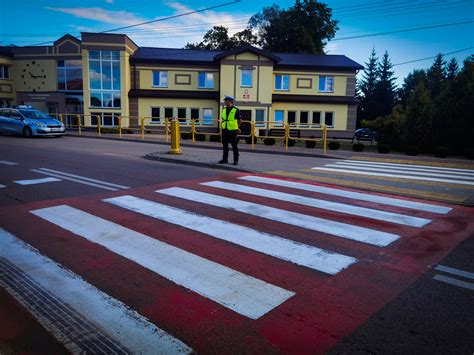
[0,229,192,354]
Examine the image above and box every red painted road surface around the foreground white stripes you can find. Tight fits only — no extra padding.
[0,175,474,353]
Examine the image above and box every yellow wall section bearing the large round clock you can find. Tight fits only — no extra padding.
[12,59,57,92]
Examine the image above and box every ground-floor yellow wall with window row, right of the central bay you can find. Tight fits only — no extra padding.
[270,102,347,131]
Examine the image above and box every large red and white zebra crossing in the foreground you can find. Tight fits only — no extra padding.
[0,174,472,353]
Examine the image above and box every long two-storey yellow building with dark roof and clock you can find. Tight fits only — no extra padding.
[0,33,363,137]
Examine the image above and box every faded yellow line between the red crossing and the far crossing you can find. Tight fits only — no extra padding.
[268,169,466,203]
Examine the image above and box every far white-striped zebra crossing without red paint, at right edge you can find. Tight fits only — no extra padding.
[312,160,474,186]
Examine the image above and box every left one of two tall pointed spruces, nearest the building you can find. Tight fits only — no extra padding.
[357,49,379,122]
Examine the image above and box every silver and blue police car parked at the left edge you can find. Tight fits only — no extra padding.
[0,106,66,137]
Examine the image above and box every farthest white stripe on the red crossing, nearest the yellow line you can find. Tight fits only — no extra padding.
[239,175,452,214]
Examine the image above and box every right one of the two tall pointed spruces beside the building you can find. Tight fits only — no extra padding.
[373,51,397,117]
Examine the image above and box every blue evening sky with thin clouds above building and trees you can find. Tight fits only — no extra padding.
[0,0,474,84]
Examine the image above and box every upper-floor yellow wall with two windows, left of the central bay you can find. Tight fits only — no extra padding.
[137,67,219,91]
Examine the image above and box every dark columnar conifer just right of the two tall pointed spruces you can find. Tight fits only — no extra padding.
[405,82,433,150]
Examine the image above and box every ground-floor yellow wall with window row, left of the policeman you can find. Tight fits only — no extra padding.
[138,98,219,126]
